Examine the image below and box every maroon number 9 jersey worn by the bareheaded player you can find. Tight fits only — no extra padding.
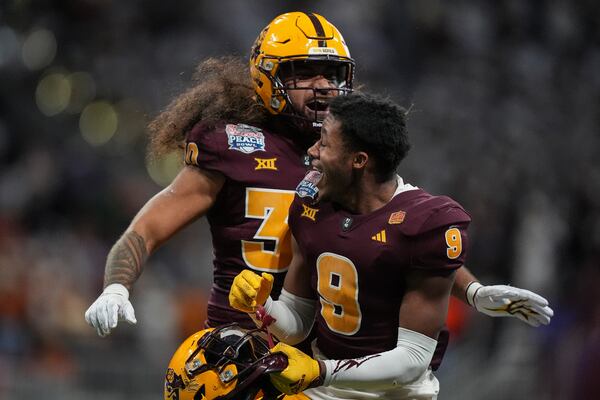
[290,189,470,359]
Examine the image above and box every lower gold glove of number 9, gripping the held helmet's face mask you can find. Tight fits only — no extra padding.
[270,342,323,394]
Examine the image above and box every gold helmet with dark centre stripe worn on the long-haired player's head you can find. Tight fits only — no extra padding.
[250,12,354,121]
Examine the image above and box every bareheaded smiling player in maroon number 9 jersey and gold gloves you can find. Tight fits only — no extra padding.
[230,94,552,400]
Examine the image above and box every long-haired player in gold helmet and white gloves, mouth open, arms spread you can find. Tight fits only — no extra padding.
[85,12,549,398]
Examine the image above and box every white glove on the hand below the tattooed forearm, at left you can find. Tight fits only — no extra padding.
[85,283,137,337]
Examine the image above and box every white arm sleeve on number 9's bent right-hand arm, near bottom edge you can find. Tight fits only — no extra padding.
[323,328,437,390]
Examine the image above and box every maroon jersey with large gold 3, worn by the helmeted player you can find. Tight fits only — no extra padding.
[185,123,306,328]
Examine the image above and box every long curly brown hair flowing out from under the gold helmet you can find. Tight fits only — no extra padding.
[148,56,269,159]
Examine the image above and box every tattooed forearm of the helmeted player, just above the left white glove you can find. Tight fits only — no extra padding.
[104,231,148,291]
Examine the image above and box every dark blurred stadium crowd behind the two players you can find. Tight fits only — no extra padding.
[0,0,600,400]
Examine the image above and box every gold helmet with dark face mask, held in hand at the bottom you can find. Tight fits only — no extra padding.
[164,323,292,400]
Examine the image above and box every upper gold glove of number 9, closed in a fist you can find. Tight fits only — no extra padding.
[229,269,273,313]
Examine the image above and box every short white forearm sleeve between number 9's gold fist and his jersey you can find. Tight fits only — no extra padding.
[248,289,317,345]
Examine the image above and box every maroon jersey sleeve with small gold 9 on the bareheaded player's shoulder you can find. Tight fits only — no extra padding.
[410,207,471,270]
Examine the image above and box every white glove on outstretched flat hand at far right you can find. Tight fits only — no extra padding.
[467,282,554,327]
